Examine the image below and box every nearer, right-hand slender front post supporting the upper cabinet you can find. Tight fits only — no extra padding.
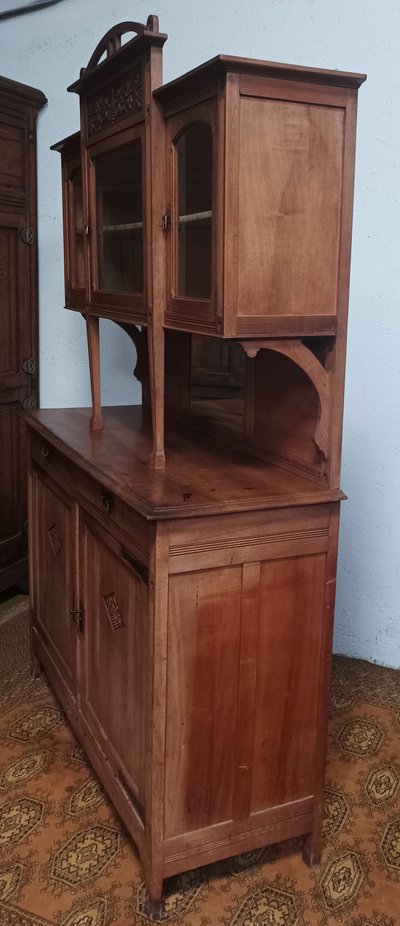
[148,321,165,469]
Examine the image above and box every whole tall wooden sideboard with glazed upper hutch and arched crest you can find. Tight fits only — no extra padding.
[29,16,365,914]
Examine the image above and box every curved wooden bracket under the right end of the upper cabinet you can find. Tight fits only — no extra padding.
[239,338,331,460]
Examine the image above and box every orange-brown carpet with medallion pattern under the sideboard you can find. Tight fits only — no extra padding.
[0,600,400,926]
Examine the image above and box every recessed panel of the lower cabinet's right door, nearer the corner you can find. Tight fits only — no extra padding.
[80,514,149,818]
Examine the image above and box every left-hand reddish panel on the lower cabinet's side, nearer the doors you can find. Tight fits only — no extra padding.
[165,566,242,837]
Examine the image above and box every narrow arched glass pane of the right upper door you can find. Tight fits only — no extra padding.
[176,122,212,299]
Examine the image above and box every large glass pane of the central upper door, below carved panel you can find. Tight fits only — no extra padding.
[94,139,143,293]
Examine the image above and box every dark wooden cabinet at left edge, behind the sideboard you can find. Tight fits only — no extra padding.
[0,77,46,591]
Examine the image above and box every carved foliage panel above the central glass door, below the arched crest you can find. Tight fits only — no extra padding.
[87,64,143,137]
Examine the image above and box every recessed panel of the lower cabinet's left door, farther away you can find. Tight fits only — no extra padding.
[32,472,77,704]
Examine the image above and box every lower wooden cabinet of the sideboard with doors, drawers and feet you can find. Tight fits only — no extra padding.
[30,447,339,913]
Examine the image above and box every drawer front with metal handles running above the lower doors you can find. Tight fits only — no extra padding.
[30,433,151,567]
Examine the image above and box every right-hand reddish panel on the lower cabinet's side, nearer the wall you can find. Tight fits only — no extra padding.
[252,554,326,812]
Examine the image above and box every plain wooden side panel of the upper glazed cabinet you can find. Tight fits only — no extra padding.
[238,97,344,316]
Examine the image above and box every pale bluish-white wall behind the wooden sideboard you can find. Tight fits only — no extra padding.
[0,0,400,666]
